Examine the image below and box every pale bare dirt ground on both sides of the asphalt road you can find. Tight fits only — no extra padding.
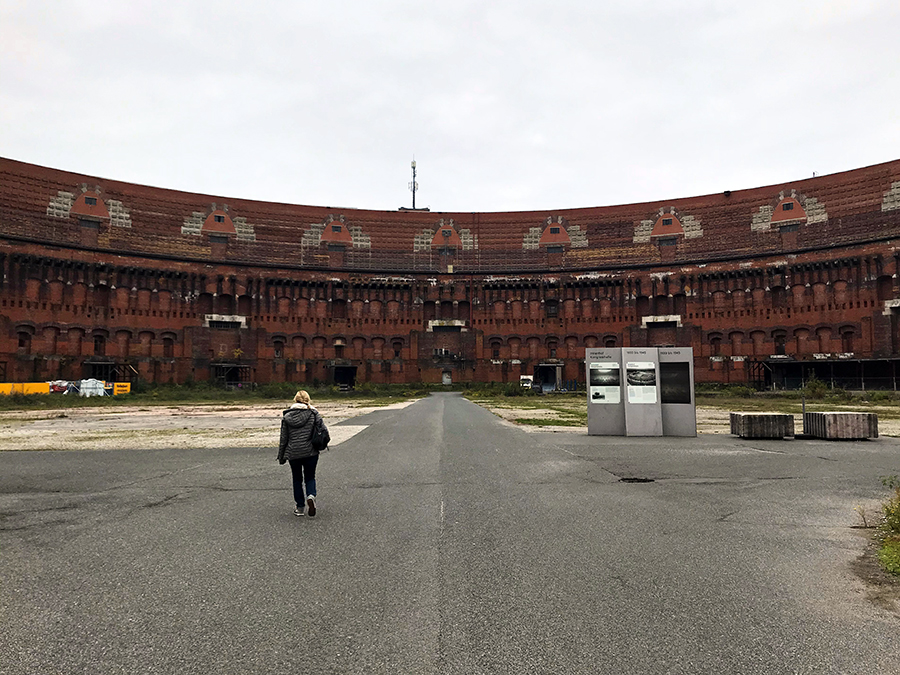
[0,401,900,451]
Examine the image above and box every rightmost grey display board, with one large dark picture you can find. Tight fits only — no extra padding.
[657,347,697,436]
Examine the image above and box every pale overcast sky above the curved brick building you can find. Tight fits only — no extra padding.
[0,0,900,211]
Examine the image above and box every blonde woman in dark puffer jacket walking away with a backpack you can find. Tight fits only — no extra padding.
[278,391,331,517]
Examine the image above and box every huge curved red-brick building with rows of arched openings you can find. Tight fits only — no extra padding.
[0,159,900,388]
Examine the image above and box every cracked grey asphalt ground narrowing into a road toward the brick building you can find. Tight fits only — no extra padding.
[0,394,900,675]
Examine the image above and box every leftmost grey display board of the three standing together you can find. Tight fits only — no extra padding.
[584,348,625,436]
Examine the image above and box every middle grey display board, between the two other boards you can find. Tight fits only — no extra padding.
[622,347,663,436]
